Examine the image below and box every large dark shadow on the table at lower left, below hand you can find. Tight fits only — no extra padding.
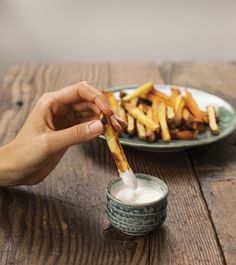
[0,188,152,264]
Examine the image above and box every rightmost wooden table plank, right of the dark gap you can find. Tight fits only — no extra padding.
[164,63,236,265]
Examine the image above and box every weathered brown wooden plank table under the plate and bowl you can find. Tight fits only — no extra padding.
[0,62,236,265]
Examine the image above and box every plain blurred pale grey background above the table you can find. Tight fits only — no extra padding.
[0,0,236,77]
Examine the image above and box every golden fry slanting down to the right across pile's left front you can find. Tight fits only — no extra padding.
[125,104,159,131]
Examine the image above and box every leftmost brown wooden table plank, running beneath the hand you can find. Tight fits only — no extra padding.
[0,64,149,265]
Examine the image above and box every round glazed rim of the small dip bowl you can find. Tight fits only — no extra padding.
[106,173,169,205]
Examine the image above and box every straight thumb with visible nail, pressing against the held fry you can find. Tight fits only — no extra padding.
[49,120,103,150]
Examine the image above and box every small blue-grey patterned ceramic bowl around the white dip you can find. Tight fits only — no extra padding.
[107,173,168,236]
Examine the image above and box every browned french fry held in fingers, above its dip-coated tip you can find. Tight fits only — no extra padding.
[100,115,130,172]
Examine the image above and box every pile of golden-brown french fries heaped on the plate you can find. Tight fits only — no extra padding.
[104,83,220,143]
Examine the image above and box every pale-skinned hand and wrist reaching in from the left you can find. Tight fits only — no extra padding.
[0,82,126,187]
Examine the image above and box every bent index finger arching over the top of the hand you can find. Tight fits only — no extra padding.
[55,81,114,116]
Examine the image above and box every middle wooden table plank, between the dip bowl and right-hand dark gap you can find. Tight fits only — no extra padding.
[111,64,223,265]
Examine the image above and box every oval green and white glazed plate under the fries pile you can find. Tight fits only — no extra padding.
[101,84,236,152]
